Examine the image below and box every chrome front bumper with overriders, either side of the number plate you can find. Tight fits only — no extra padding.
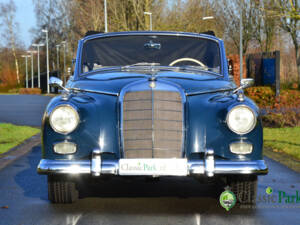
[37,150,268,177]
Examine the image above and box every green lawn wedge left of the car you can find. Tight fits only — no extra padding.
[0,123,40,154]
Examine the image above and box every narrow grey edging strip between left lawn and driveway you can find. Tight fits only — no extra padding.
[0,133,41,170]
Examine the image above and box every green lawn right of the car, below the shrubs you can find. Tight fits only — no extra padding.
[264,127,300,160]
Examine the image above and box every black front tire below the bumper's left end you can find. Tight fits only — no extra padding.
[48,176,79,203]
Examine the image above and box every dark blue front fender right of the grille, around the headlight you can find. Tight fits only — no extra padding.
[186,94,263,160]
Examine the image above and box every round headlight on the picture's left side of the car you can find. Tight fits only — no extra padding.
[50,105,79,134]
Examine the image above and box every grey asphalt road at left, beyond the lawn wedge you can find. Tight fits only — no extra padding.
[0,95,51,127]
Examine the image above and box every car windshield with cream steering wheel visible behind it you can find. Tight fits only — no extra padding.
[81,35,221,73]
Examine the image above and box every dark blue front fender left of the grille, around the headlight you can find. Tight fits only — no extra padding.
[42,94,120,160]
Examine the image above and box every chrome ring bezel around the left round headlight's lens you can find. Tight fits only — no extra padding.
[49,104,80,134]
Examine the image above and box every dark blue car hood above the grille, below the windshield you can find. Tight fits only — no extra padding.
[71,71,235,95]
